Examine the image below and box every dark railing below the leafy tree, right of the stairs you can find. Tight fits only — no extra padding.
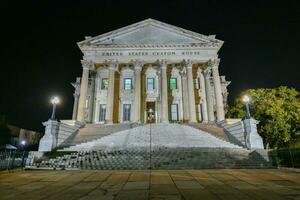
[269,148,300,168]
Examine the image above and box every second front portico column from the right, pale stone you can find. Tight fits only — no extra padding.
[186,60,197,122]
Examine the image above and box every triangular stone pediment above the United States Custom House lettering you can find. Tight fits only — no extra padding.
[78,19,223,47]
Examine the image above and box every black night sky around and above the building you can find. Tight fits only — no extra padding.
[0,0,300,130]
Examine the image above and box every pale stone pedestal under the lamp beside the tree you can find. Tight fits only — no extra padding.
[243,118,264,150]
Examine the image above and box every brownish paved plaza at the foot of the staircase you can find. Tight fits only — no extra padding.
[0,169,300,200]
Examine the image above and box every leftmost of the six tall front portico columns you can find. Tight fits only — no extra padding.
[77,60,92,122]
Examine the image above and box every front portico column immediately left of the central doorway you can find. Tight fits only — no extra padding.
[133,61,143,122]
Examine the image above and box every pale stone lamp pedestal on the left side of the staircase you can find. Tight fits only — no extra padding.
[39,119,60,152]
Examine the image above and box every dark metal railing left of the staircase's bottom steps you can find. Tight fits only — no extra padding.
[0,150,28,170]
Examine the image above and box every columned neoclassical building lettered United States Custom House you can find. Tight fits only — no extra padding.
[72,19,230,124]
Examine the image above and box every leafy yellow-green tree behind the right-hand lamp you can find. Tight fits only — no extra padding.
[227,86,300,148]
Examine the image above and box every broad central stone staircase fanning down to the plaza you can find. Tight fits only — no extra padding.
[31,124,270,169]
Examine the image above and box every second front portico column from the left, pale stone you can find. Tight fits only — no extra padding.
[105,62,118,124]
